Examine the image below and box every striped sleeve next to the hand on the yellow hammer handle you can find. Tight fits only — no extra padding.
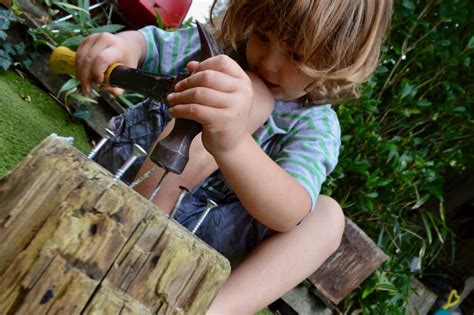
[139,26,201,76]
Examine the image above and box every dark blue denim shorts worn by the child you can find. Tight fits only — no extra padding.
[95,100,271,266]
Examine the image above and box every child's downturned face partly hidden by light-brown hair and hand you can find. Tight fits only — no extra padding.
[246,30,313,101]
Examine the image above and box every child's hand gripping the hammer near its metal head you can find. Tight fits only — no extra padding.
[168,55,253,155]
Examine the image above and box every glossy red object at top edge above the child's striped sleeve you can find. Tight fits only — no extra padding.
[118,0,192,28]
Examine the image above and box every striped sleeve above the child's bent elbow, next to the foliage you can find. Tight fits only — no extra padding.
[274,105,341,209]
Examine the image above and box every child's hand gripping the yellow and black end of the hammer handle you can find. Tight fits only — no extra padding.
[76,31,146,95]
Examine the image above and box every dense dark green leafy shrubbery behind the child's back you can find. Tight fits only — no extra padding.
[324,0,474,314]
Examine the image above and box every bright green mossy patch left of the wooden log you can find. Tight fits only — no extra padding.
[0,71,91,176]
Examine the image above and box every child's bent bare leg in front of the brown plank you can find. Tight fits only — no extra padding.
[207,196,344,315]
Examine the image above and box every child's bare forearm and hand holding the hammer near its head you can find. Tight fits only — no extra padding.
[168,56,311,231]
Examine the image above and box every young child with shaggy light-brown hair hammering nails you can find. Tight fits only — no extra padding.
[76,0,392,314]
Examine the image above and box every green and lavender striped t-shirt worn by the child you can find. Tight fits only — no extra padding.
[140,26,341,209]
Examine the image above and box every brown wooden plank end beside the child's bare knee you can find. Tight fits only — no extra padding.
[309,218,388,304]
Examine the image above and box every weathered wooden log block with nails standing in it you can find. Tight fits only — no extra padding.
[0,136,230,314]
